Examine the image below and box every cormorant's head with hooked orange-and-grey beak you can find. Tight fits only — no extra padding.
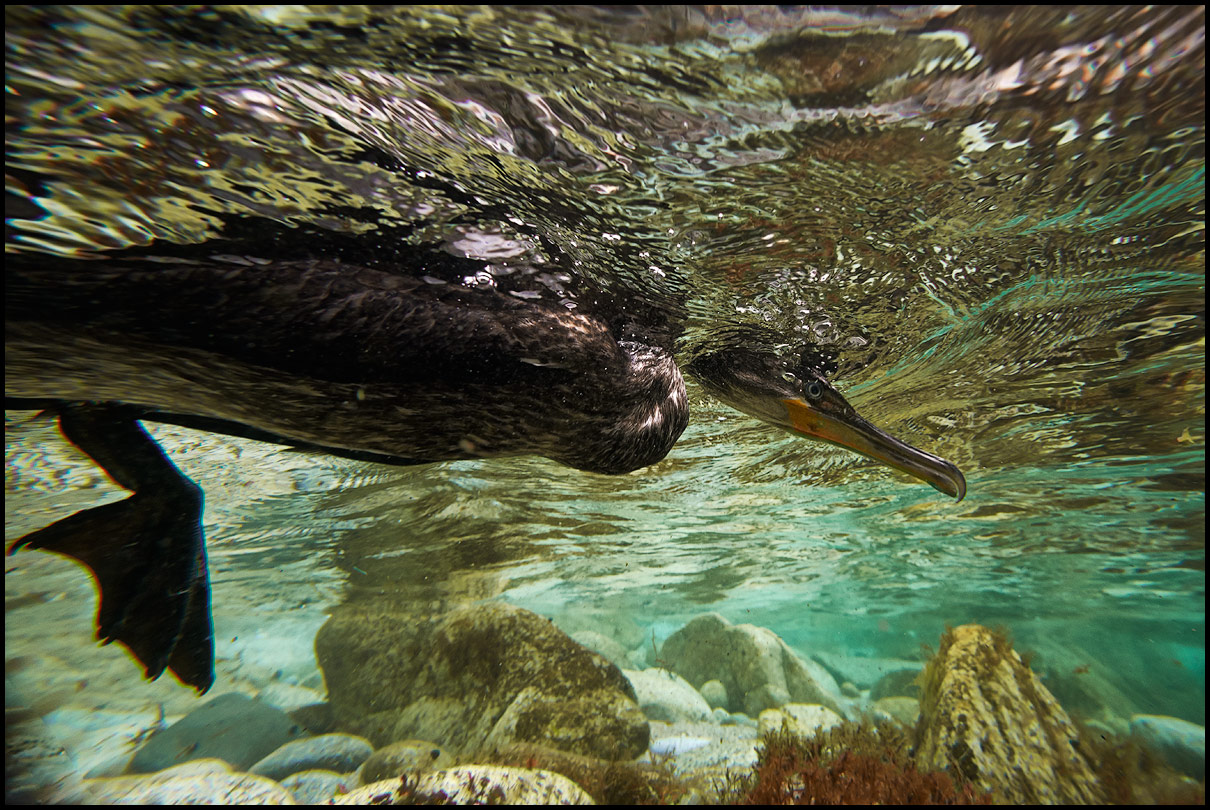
[686,327,967,500]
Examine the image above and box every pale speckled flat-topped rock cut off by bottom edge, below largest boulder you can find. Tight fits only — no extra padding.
[333,765,594,804]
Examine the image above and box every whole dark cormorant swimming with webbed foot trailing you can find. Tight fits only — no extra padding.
[5,244,966,691]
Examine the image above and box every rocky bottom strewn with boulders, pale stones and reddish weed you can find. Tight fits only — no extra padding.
[6,569,1205,804]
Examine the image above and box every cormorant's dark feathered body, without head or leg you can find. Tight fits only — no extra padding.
[5,259,688,473]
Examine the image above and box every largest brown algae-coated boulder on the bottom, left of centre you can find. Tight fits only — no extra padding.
[316,603,649,759]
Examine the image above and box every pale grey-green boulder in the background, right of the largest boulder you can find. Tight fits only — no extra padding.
[659,613,845,717]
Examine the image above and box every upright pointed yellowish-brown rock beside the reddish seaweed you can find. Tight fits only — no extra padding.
[915,625,1102,804]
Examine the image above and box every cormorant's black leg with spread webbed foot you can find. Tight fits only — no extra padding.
[10,403,214,693]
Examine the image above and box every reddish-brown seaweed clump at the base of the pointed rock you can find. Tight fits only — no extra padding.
[730,722,992,804]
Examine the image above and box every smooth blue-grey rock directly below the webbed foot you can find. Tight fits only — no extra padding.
[127,693,306,774]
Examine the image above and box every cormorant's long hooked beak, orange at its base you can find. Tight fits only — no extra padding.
[782,397,967,500]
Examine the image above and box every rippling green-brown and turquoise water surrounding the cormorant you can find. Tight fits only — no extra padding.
[5,6,1205,799]
